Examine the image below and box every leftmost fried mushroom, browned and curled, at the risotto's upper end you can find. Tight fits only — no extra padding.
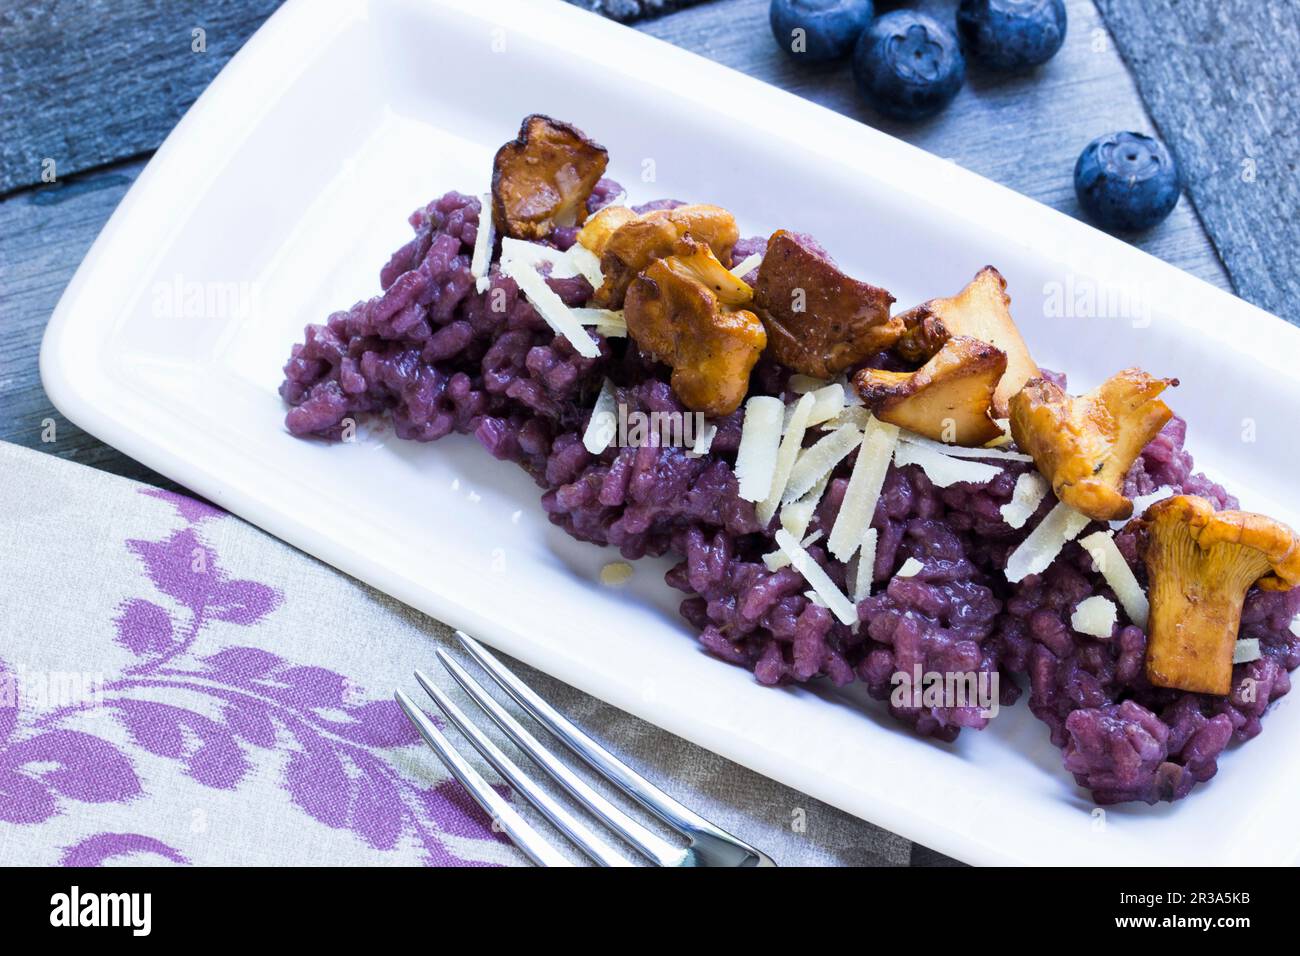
[491,113,610,239]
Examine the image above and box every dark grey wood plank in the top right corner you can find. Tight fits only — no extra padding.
[1099,0,1300,324]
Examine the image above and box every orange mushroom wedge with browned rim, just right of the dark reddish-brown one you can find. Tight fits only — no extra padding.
[853,336,1006,446]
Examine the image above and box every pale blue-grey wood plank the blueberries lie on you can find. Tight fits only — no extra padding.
[638,0,1230,287]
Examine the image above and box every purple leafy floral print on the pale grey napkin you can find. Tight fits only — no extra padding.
[0,489,504,866]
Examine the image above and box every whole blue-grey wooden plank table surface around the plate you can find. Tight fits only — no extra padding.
[0,0,1300,868]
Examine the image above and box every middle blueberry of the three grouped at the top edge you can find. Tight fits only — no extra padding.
[853,10,966,120]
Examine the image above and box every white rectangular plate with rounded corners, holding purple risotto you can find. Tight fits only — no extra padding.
[42,0,1300,864]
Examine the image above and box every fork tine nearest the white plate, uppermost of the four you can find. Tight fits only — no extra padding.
[456,631,743,857]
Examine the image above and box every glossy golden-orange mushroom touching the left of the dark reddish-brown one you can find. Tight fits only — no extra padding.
[623,237,767,415]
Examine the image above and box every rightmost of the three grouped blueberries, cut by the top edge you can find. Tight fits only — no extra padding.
[957,0,1065,72]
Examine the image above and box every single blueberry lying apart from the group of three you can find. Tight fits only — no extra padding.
[1074,133,1183,233]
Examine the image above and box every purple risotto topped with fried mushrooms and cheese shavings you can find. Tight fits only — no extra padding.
[281,117,1300,804]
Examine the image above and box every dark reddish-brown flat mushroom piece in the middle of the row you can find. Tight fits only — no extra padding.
[754,229,904,378]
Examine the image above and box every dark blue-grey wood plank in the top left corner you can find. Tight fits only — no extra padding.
[0,0,280,194]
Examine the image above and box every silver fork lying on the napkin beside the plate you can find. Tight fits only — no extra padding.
[394,631,776,866]
